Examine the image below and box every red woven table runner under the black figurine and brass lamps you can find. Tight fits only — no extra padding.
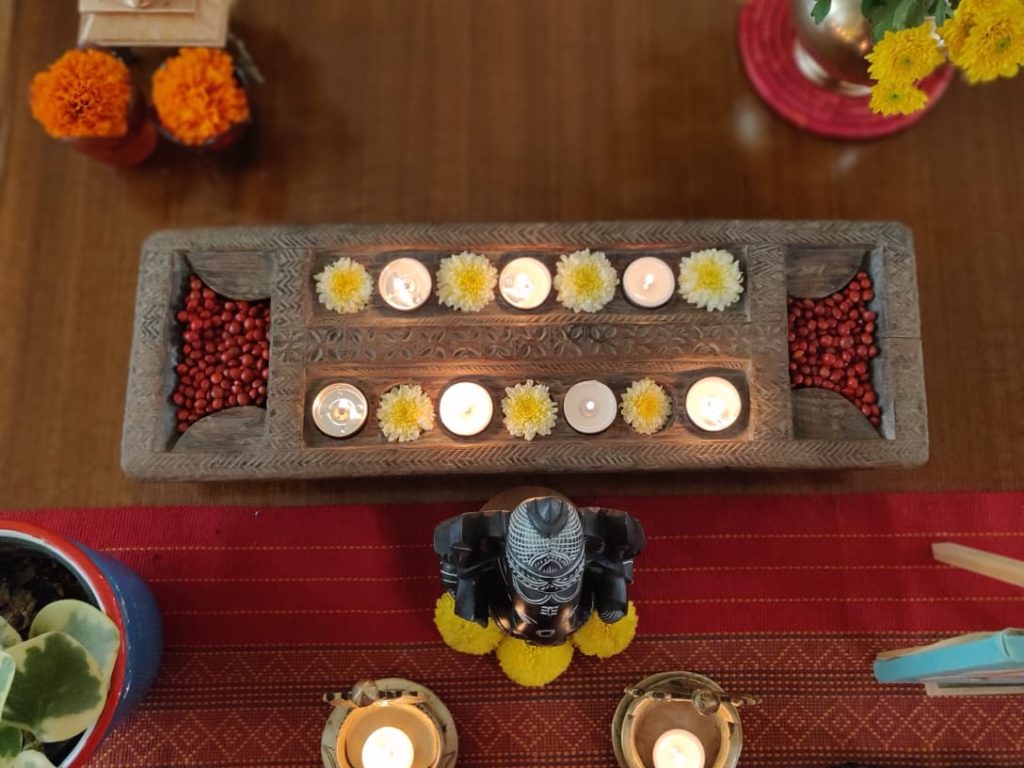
[4,495,1024,768]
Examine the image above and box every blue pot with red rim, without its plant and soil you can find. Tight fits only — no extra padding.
[0,520,163,768]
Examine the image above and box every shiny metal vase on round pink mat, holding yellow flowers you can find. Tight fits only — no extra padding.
[790,0,872,96]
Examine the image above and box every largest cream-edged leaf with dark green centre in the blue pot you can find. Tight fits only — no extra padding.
[3,632,110,743]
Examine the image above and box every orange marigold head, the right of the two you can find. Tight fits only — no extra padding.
[153,48,249,145]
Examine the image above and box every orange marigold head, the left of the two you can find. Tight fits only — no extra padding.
[29,48,132,138]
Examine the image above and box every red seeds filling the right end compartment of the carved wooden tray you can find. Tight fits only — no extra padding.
[787,272,882,427]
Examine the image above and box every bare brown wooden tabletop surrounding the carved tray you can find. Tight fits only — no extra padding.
[0,0,1024,508]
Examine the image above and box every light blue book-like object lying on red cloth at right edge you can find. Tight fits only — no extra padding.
[874,630,1024,693]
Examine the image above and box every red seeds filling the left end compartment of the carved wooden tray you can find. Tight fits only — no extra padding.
[171,275,270,432]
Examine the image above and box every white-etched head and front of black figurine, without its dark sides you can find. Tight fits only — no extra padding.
[503,498,585,644]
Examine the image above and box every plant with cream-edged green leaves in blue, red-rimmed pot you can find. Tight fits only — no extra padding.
[0,521,163,768]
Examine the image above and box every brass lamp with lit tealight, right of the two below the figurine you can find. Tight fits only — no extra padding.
[611,672,758,768]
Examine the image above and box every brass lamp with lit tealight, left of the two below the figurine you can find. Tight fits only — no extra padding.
[321,678,459,768]
